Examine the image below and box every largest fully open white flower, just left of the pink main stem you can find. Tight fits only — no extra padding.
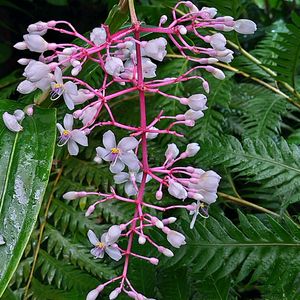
[96,130,139,173]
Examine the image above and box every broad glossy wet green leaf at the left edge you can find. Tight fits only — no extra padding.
[0,100,56,295]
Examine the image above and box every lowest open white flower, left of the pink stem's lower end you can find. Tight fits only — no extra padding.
[88,225,122,261]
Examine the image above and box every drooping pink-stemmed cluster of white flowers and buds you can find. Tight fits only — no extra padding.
[3,1,256,300]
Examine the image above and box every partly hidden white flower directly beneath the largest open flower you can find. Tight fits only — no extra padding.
[114,171,151,197]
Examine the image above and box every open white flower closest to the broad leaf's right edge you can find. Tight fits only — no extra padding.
[56,114,88,155]
